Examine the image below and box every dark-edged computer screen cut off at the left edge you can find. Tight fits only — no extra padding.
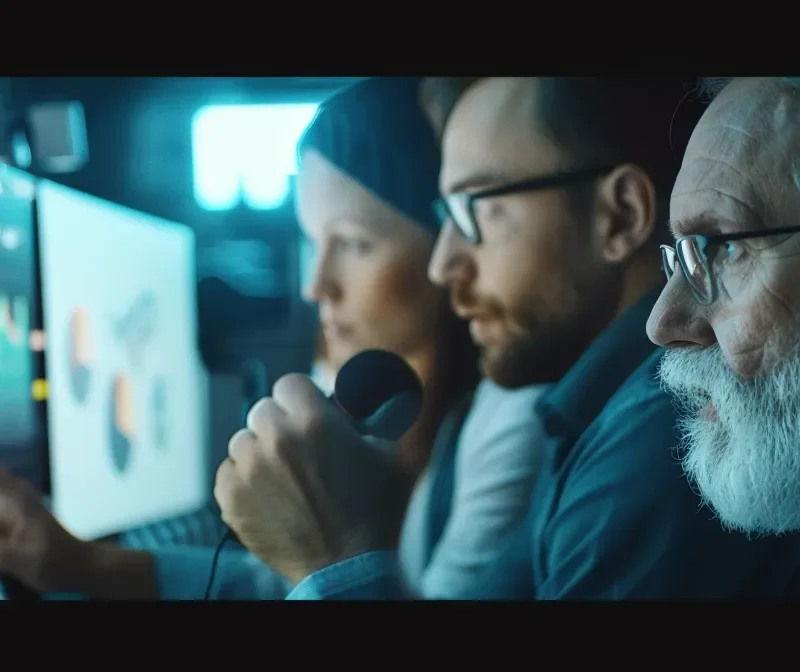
[0,163,46,490]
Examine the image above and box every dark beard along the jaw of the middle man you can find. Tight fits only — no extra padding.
[481,269,622,389]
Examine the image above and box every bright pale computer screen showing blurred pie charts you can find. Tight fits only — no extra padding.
[37,181,210,538]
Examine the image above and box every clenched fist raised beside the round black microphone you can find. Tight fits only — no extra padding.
[214,375,412,582]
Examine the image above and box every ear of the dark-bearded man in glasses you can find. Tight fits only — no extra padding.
[595,164,657,264]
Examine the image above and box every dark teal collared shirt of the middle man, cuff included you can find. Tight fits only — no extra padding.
[288,292,800,600]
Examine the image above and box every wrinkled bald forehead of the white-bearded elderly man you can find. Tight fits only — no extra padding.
[673,78,800,224]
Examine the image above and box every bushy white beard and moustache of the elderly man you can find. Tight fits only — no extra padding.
[660,346,800,535]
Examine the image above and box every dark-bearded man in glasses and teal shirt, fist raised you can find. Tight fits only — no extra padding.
[208,78,800,599]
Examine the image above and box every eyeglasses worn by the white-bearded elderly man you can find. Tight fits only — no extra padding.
[661,226,800,306]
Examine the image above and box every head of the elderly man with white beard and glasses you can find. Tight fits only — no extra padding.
[648,78,800,535]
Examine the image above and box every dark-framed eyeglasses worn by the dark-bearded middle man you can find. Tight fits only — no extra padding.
[433,166,615,245]
